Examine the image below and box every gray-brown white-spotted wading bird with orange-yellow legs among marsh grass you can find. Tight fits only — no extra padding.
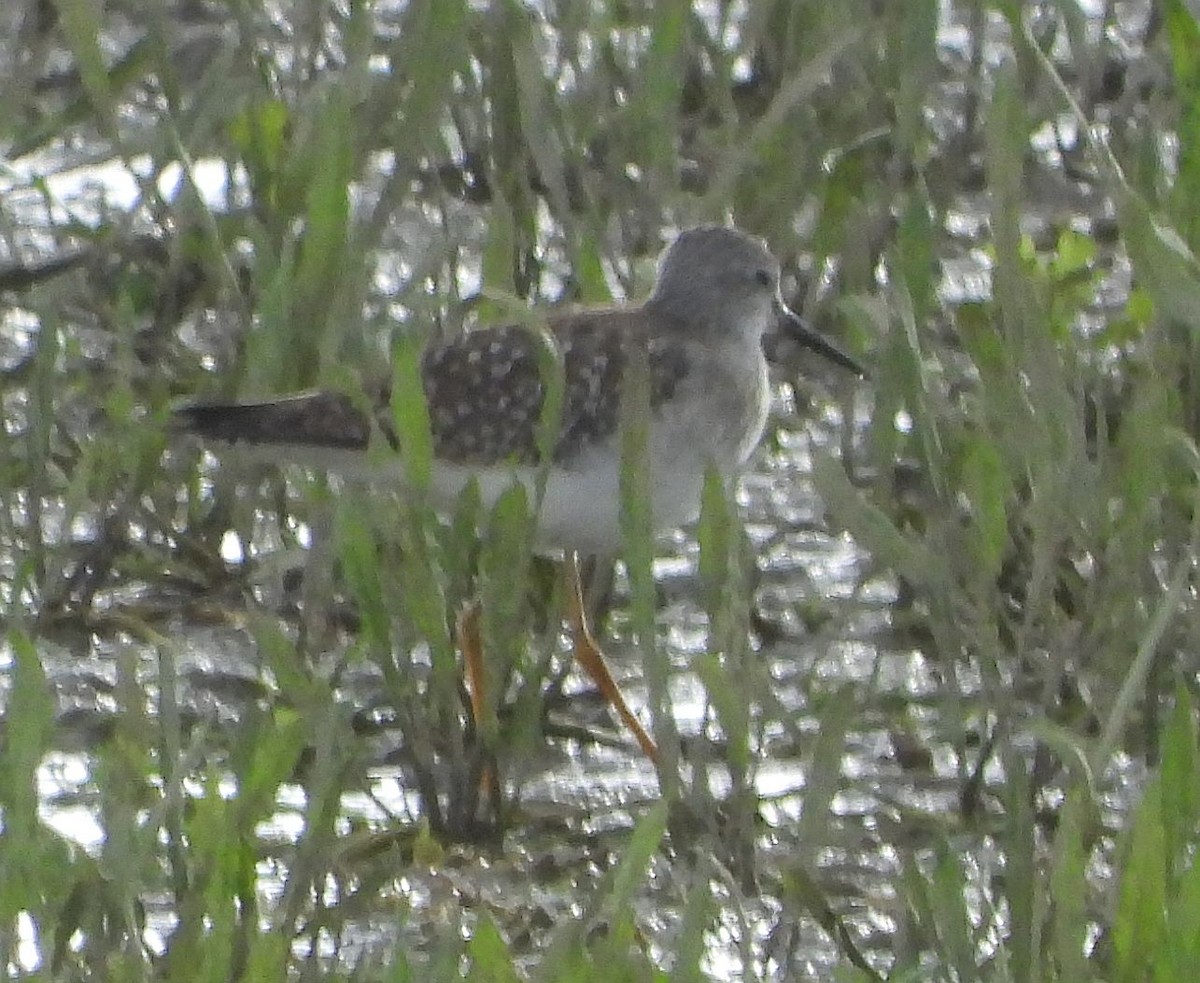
[172,226,866,760]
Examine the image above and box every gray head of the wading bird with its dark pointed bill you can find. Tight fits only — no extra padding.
[646,226,866,376]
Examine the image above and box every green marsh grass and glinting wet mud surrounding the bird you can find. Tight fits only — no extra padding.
[0,0,1200,981]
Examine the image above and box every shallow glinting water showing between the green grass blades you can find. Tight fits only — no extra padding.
[0,4,1161,978]
